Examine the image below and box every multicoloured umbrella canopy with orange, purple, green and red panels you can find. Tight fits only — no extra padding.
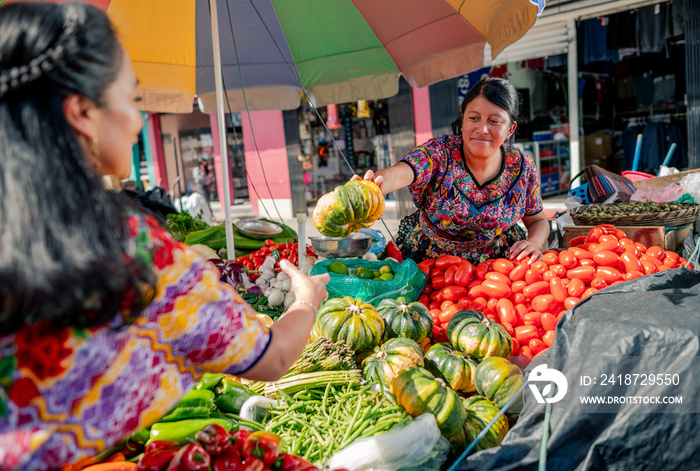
[107,0,544,113]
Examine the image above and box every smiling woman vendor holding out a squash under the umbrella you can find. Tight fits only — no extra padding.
[353,77,549,263]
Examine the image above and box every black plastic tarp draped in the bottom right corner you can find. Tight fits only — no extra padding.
[459,269,700,471]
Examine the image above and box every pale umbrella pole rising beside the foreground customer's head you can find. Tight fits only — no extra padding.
[209,0,236,260]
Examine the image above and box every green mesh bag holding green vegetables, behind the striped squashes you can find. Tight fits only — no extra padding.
[311,258,426,306]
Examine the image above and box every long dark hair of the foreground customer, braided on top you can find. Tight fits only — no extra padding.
[0,2,153,336]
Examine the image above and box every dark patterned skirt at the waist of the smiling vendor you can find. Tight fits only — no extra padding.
[396,211,527,264]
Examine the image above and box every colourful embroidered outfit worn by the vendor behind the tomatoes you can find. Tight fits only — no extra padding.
[401,134,542,260]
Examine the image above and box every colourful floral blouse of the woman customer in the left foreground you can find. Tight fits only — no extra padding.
[0,216,271,471]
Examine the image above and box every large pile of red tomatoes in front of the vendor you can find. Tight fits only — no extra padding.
[418,224,687,357]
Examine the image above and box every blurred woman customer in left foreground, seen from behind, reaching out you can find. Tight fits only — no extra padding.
[0,2,328,470]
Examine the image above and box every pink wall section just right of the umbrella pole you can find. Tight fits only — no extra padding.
[241,111,292,213]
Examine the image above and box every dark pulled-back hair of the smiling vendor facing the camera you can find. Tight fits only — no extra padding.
[452,77,520,147]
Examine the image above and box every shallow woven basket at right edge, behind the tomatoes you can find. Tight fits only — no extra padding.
[570,204,700,227]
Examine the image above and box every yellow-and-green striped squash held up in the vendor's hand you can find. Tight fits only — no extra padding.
[311,180,384,237]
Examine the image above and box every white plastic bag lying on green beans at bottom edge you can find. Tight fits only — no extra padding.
[326,414,450,471]
